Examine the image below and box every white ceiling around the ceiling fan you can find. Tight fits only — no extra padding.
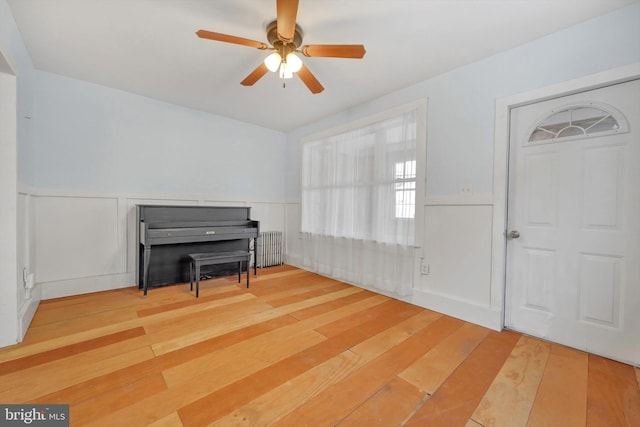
[8,0,638,131]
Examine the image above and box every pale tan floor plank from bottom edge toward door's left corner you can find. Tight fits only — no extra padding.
[471,336,551,427]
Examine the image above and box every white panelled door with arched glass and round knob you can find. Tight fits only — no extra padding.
[505,80,640,365]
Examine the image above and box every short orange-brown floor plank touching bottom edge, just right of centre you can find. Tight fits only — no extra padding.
[337,377,429,427]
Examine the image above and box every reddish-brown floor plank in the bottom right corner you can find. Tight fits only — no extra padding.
[587,354,640,427]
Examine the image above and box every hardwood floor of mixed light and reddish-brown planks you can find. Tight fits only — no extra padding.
[0,266,640,427]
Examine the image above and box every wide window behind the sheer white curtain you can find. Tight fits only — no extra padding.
[302,110,417,244]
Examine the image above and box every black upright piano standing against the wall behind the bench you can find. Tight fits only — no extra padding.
[136,205,260,295]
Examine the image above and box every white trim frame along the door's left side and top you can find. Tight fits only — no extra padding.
[491,62,640,329]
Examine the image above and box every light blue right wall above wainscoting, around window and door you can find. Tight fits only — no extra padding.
[286,3,640,201]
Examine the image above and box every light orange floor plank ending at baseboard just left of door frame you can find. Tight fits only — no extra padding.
[398,324,489,394]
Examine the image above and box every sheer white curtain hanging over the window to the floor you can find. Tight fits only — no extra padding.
[302,109,418,295]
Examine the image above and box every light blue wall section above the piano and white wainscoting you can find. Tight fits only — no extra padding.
[32,71,285,201]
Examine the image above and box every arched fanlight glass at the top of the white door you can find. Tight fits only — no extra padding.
[528,103,629,144]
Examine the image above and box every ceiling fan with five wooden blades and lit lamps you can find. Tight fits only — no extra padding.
[196,0,366,94]
